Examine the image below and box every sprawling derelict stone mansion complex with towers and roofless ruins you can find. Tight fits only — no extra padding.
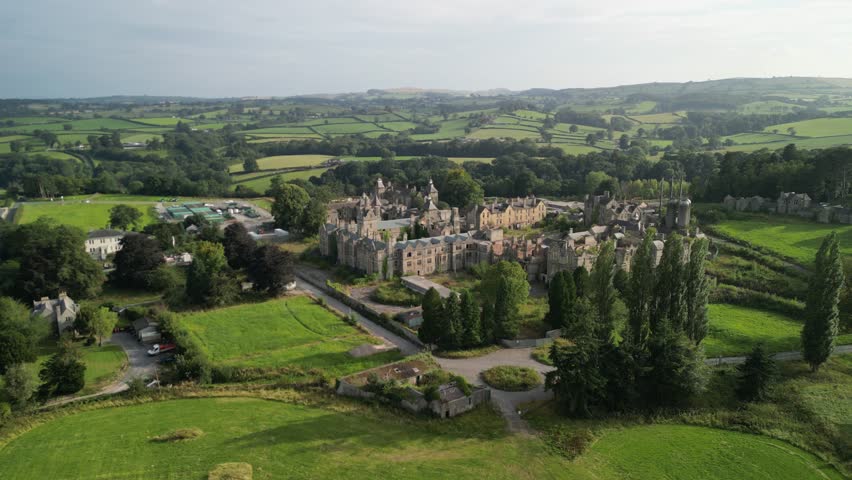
[319,182,700,282]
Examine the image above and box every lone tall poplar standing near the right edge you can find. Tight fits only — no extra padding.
[802,232,845,372]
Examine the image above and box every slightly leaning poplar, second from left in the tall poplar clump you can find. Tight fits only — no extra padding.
[626,230,656,348]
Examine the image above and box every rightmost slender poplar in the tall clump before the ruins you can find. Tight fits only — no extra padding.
[684,238,710,345]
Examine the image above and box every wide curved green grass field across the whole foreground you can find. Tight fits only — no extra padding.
[0,397,842,480]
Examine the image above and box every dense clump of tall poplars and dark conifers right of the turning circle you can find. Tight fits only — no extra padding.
[546,230,710,416]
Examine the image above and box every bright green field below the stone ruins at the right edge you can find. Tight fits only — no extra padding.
[714,214,852,265]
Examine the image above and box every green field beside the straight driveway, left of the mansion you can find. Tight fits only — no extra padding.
[182,297,399,375]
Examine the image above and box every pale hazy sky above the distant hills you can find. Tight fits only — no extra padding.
[0,0,852,98]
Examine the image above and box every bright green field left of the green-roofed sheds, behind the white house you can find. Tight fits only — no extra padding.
[15,200,156,231]
